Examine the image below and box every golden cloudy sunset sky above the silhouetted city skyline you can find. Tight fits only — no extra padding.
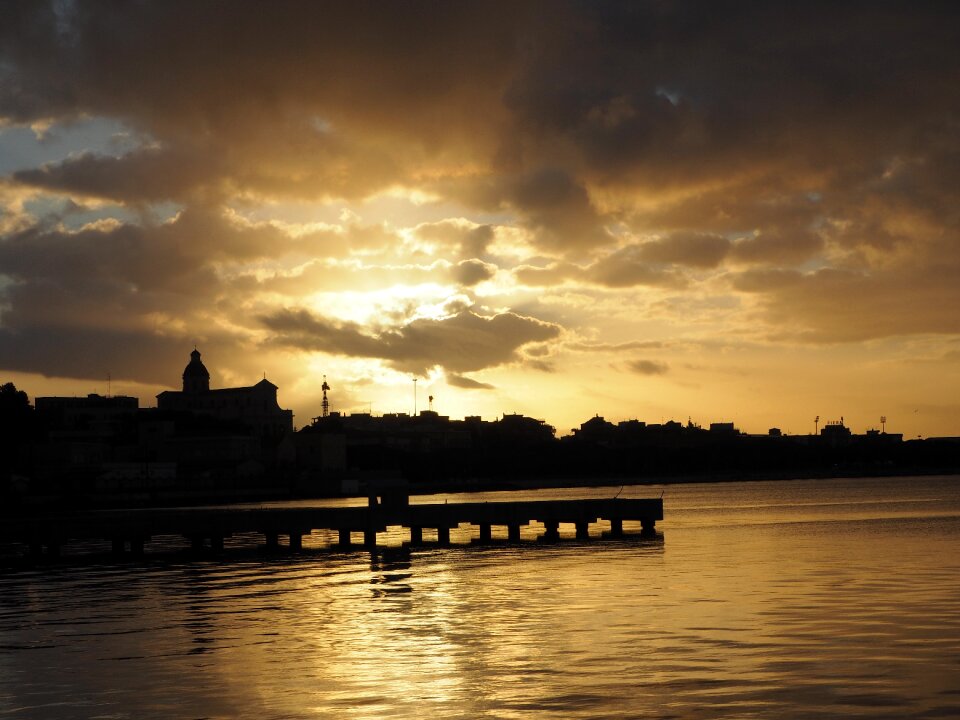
[0,0,960,437]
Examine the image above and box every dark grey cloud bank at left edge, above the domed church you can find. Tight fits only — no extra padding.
[0,205,304,382]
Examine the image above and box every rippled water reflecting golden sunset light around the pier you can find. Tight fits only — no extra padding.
[0,478,960,718]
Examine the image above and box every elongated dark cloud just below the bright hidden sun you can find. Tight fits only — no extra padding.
[260,310,561,375]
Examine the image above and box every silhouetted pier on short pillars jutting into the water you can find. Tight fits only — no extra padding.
[0,494,663,557]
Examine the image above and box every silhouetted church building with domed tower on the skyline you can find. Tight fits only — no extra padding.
[157,349,293,437]
